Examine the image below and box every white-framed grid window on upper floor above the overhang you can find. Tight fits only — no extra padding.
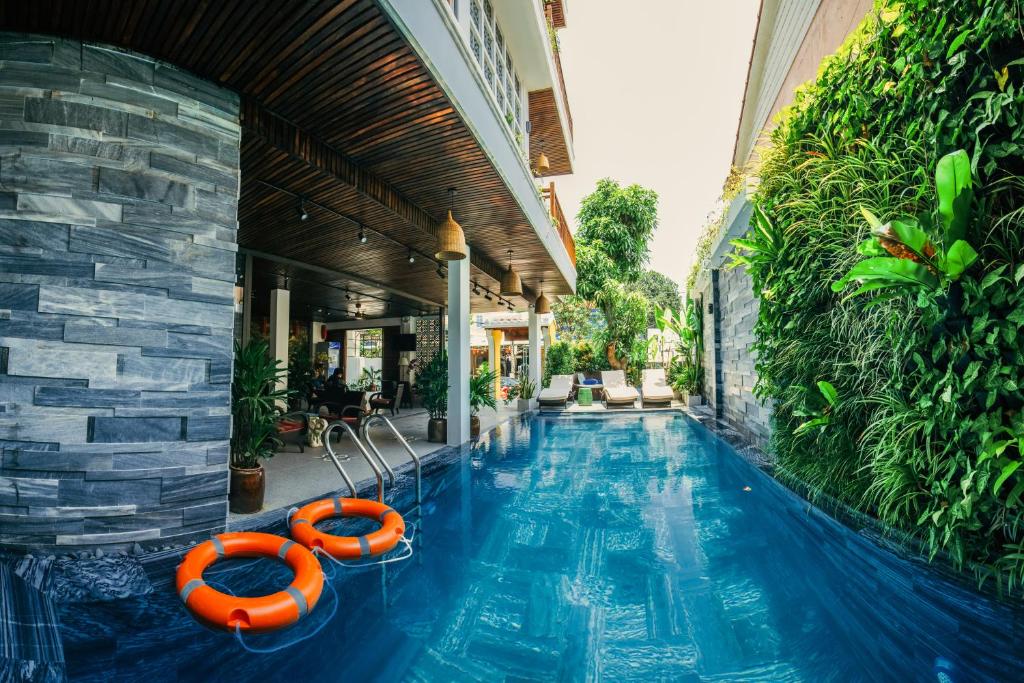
[469,0,526,150]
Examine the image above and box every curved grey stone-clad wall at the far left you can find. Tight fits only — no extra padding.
[0,34,240,550]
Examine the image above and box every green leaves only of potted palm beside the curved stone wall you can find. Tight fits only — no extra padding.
[231,341,291,469]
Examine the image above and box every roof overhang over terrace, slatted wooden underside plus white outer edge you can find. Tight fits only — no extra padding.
[0,0,575,310]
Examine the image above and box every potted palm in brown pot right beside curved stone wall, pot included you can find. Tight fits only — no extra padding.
[228,340,291,513]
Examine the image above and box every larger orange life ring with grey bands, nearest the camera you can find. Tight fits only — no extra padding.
[177,531,324,632]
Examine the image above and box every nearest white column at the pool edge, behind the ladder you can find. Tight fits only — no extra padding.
[447,249,470,445]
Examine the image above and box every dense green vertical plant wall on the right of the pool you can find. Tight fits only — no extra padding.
[737,0,1024,590]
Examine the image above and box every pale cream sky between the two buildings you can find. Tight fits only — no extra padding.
[554,0,760,287]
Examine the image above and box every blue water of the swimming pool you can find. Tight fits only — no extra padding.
[61,414,1024,683]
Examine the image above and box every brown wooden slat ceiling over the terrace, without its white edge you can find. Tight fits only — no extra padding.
[0,0,569,310]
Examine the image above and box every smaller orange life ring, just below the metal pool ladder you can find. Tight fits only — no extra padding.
[288,498,406,559]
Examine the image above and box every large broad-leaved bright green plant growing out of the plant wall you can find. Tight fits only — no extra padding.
[831,150,978,303]
